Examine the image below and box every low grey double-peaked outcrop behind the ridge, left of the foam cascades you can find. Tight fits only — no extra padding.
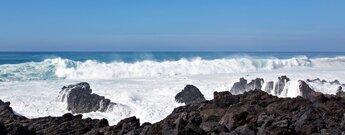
[230,78,264,94]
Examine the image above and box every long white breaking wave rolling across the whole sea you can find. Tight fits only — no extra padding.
[0,56,345,81]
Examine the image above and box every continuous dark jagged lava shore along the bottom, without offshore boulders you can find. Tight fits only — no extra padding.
[0,86,345,135]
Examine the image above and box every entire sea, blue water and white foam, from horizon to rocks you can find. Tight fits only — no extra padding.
[0,52,345,124]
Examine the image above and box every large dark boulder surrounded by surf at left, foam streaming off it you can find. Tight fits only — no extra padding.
[58,82,117,113]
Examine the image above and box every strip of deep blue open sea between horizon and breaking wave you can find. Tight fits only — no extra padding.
[0,52,345,64]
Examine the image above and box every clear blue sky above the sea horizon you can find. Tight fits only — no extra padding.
[0,0,345,52]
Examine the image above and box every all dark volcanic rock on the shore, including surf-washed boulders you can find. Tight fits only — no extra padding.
[0,76,345,135]
